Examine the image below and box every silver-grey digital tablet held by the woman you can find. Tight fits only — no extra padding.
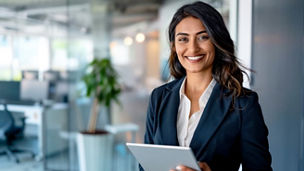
[126,143,200,171]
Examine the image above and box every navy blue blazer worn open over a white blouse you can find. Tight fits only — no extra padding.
[144,79,272,171]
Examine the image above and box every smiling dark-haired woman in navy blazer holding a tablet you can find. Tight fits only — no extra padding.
[145,2,272,171]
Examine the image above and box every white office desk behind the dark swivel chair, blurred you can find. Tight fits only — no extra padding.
[0,104,68,160]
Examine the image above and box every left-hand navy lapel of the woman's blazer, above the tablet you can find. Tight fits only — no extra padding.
[158,79,184,146]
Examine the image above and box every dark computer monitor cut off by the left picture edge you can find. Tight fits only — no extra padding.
[0,81,20,103]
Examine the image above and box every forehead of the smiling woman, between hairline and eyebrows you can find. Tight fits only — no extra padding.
[175,16,206,34]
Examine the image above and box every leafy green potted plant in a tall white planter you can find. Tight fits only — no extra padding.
[77,58,121,171]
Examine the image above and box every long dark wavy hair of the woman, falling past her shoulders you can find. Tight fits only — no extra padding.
[169,1,251,97]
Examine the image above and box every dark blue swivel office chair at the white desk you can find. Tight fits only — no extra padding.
[0,104,35,163]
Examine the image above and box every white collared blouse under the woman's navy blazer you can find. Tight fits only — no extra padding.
[177,78,216,147]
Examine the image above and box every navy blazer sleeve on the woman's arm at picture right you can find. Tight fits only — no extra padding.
[241,93,272,171]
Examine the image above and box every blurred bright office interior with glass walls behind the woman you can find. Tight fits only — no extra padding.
[0,0,304,171]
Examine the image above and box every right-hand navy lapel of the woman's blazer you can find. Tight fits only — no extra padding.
[190,83,232,157]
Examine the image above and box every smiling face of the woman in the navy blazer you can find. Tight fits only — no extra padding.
[174,17,215,74]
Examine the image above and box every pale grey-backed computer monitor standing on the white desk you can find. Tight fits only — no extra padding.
[21,80,49,102]
